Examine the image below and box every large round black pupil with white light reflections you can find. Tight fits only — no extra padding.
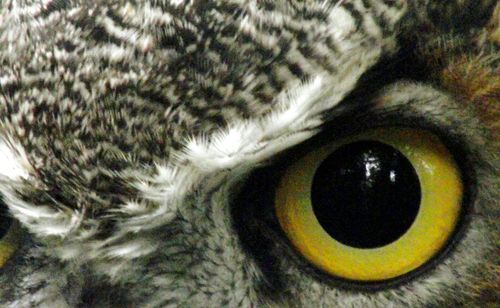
[311,141,421,248]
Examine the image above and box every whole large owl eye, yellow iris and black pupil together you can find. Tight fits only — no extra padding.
[274,128,464,282]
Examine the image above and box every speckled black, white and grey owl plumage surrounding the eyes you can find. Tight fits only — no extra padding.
[0,0,499,307]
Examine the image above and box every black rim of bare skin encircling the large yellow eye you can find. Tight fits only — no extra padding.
[233,119,476,292]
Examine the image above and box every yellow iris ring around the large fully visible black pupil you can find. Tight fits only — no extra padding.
[275,128,463,282]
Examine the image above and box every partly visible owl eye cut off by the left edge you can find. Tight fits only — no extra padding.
[0,200,21,268]
